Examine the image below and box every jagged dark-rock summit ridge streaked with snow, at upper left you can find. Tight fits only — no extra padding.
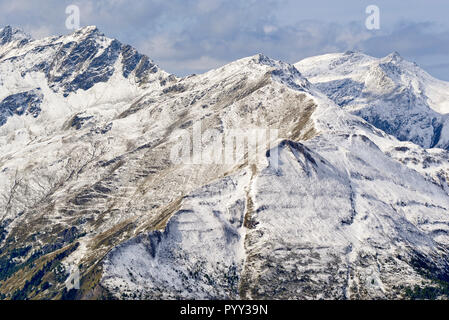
[0,26,168,103]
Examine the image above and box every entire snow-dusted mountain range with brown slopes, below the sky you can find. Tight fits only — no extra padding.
[0,27,449,299]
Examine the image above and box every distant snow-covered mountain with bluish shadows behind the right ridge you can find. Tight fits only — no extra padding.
[295,51,449,149]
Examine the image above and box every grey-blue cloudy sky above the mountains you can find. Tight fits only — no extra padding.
[0,0,449,81]
